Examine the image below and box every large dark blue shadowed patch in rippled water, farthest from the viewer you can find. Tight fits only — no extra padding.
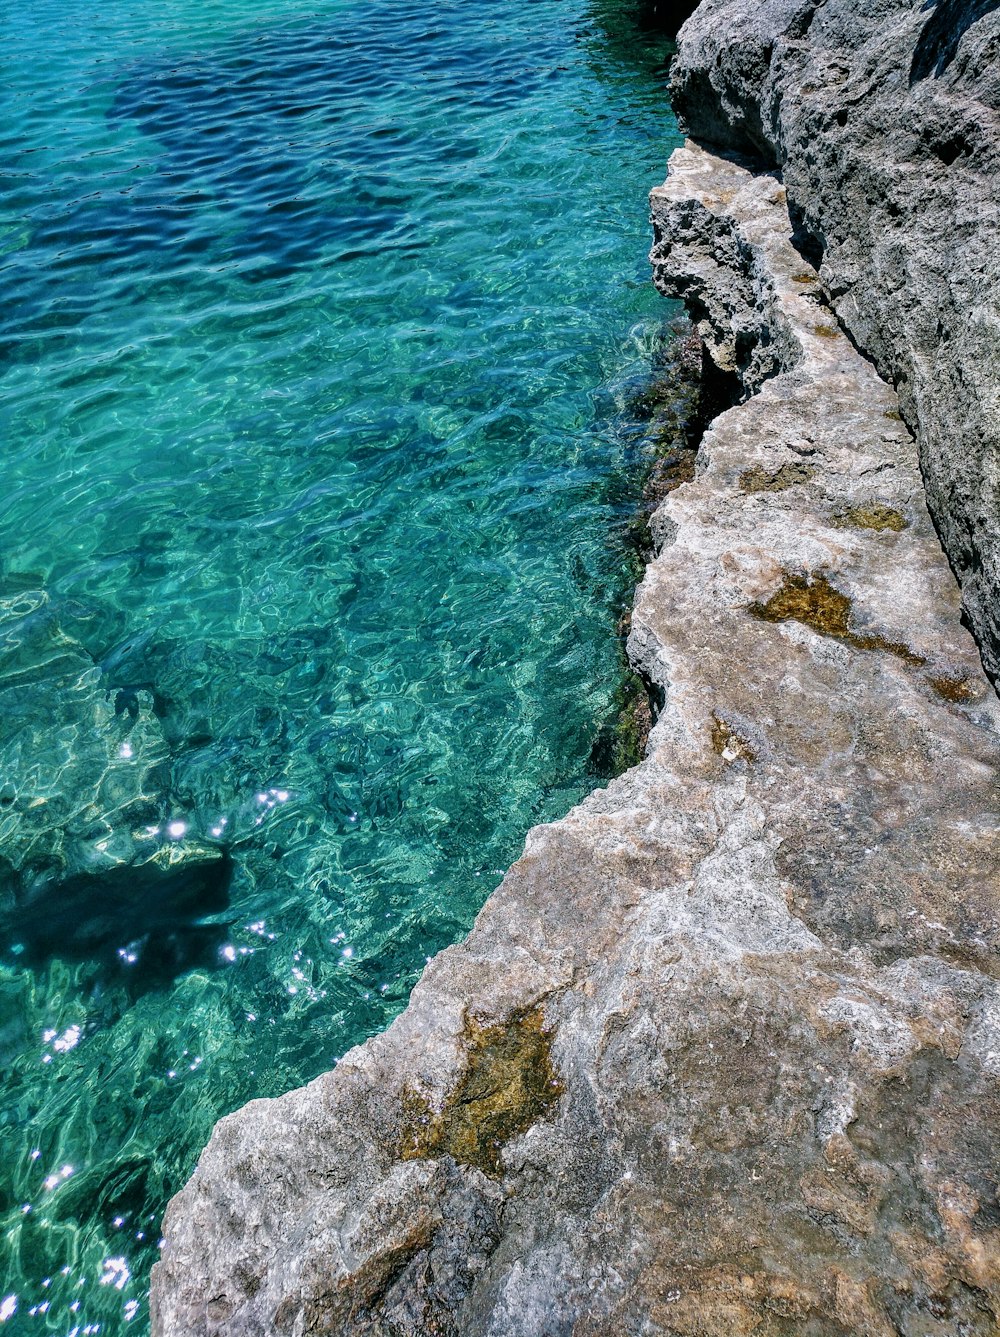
[0,0,555,368]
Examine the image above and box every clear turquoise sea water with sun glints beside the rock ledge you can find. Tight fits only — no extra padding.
[0,0,676,1337]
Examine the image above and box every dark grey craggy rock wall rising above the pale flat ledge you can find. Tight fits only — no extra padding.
[672,0,1000,679]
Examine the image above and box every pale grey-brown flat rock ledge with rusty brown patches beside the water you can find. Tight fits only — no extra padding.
[152,150,1000,1337]
